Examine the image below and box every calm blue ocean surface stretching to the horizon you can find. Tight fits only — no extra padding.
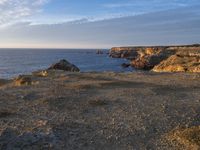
[0,49,133,78]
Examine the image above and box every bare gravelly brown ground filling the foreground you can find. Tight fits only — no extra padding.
[0,71,200,150]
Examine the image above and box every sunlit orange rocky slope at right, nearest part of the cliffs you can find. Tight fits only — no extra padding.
[153,55,200,72]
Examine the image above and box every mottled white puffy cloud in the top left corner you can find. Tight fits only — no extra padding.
[0,0,47,26]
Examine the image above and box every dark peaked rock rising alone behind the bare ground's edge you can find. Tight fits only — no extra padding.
[48,59,80,72]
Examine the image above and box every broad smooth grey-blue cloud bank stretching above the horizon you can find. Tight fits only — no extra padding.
[0,6,200,48]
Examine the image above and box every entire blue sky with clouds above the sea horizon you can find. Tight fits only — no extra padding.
[0,0,200,48]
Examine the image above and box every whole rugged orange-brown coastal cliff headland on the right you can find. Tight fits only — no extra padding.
[110,44,200,72]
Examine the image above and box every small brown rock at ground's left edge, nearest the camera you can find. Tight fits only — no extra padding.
[14,75,33,86]
